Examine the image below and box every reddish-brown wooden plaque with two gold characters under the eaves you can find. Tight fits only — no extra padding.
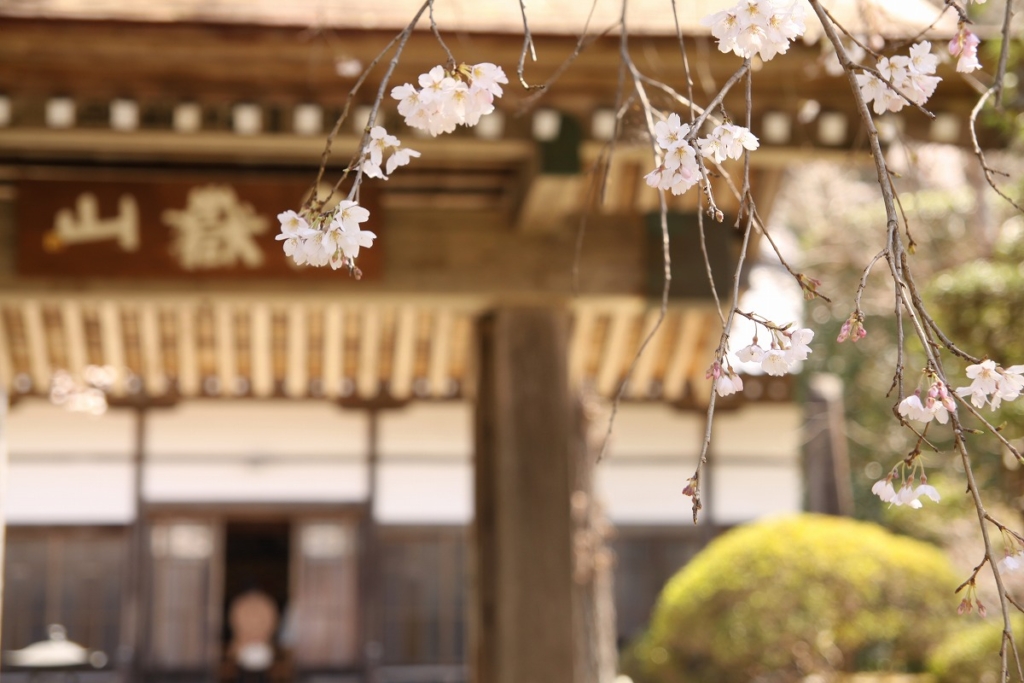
[15,179,383,280]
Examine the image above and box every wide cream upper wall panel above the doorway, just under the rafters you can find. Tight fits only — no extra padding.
[146,400,368,459]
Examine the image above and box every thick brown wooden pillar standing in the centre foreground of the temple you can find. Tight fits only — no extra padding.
[470,308,583,683]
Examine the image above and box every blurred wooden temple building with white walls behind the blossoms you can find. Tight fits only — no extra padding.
[0,0,971,683]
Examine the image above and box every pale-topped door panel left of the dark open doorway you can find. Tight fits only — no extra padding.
[146,519,221,676]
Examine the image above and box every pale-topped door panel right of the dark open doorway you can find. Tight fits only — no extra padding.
[287,516,359,671]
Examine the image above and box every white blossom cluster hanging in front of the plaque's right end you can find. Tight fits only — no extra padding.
[276,200,377,270]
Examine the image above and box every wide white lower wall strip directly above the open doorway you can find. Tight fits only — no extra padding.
[142,460,367,503]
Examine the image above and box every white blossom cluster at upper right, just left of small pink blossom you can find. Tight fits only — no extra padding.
[857,40,942,115]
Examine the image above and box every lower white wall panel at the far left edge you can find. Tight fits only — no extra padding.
[3,460,135,524]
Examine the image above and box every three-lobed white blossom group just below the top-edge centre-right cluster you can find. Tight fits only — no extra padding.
[644,114,758,195]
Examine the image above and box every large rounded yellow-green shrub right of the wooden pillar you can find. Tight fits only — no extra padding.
[624,515,957,683]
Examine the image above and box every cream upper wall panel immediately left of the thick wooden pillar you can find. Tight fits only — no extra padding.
[378,401,473,460]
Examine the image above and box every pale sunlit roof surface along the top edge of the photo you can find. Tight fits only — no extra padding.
[0,0,955,36]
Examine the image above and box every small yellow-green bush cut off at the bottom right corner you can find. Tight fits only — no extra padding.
[928,610,1024,683]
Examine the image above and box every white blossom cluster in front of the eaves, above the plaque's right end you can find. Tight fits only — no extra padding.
[391,61,509,136]
